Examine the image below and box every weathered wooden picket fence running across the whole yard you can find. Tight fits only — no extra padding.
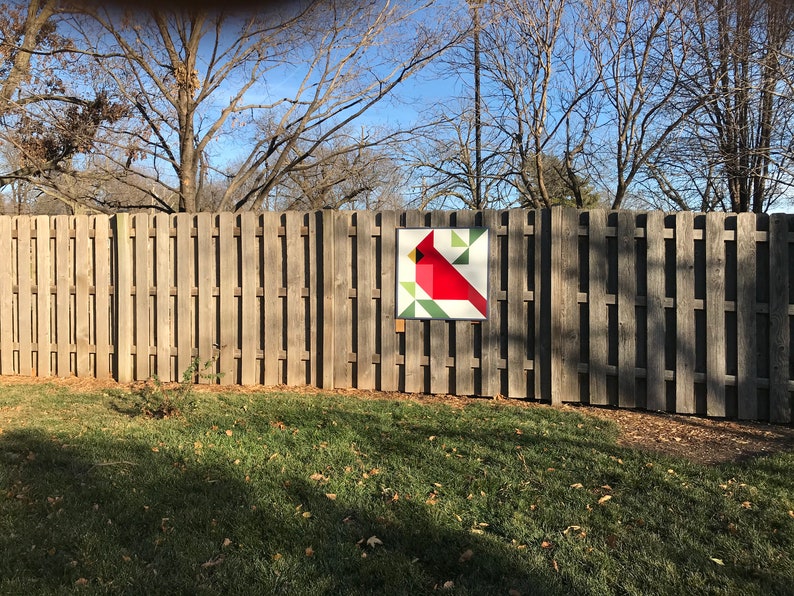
[0,208,794,423]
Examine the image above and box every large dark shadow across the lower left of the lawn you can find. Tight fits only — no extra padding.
[0,430,565,594]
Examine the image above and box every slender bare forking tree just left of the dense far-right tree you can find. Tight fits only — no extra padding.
[583,0,710,209]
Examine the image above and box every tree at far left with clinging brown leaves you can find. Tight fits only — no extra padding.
[0,0,125,210]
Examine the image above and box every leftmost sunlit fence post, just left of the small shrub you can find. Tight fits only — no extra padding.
[112,213,133,383]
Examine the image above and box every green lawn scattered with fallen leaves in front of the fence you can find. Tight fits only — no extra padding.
[0,385,794,595]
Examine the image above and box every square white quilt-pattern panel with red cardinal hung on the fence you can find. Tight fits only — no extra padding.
[396,228,488,320]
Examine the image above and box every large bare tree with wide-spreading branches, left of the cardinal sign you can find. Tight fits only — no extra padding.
[72,0,458,211]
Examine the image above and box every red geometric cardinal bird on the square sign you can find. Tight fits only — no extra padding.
[414,232,488,317]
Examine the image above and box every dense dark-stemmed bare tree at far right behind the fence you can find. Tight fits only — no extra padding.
[650,0,794,213]
